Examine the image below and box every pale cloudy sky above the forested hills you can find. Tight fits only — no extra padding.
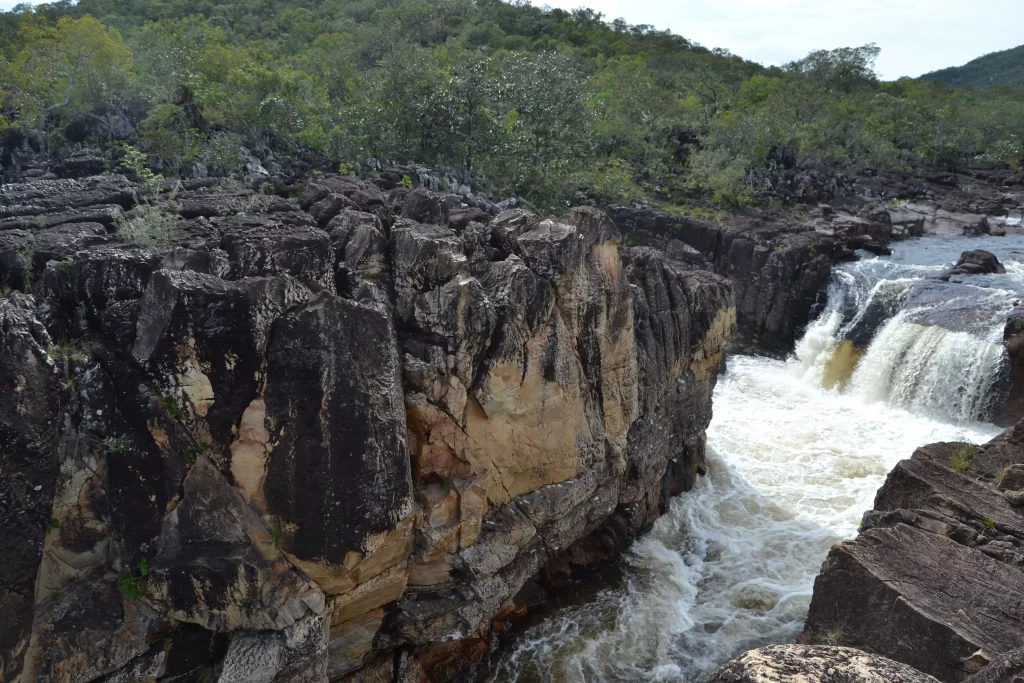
[6,0,1024,79]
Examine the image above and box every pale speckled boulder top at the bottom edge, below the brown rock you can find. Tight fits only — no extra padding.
[706,645,937,683]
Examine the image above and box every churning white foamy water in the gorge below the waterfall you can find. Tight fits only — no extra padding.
[488,357,997,683]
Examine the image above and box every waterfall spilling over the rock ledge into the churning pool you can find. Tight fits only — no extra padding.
[796,237,1024,424]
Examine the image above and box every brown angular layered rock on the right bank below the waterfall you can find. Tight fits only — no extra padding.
[804,423,1024,681]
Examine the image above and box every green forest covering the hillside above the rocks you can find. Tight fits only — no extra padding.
[0,0,1024,207]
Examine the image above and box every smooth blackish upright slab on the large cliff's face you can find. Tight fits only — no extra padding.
[258,293,412,580]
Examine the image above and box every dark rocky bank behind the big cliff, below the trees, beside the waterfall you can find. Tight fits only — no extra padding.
[609,165,1024,356]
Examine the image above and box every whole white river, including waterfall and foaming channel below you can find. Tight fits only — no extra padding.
[472,238,1024,683]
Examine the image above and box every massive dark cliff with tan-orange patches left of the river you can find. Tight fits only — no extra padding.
[0,176,735,683]
